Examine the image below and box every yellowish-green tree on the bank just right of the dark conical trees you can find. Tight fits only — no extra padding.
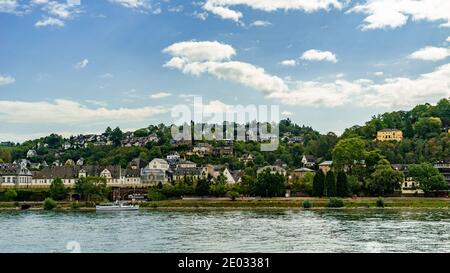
[367,159,404,196]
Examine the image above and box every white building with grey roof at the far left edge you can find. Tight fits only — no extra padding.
[0,163,32,187]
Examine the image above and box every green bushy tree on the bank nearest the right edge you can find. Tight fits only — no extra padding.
[409,163,448,193]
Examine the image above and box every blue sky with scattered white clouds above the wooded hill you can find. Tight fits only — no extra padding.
[0,0,450,142]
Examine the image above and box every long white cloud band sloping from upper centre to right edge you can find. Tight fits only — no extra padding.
[165,39,450,107]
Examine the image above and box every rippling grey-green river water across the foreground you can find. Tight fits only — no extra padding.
[0,209,450,253]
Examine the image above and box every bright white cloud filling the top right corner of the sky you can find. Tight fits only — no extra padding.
[347,0,450,30]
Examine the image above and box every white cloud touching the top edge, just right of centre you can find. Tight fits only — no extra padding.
[203,0,344,22]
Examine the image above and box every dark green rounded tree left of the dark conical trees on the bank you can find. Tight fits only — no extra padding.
[255,170,285,197]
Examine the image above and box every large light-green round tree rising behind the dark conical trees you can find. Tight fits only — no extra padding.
[332,137,366,172]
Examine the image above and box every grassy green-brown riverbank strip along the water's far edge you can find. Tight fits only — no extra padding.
[0,197,450,211]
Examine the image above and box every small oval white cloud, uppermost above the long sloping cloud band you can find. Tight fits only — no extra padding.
[163,41,236,62]
